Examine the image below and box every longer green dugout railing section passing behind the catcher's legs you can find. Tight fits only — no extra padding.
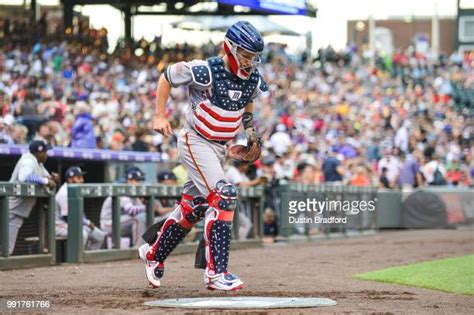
[66,184,264,263]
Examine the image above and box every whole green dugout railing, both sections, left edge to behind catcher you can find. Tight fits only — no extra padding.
[0,182,264,270]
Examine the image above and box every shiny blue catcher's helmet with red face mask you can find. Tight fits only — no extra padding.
[224,21,263,80]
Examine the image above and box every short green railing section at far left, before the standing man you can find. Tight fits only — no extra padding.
[0,182,56,270]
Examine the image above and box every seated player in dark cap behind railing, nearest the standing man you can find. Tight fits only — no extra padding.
[56,166,106,250]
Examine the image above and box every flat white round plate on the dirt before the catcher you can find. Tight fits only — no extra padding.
[145,296,337,309]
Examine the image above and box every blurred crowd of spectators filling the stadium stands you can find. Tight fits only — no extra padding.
[0,17,474,188]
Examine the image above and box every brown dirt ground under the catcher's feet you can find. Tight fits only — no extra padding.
[0,227,474,314]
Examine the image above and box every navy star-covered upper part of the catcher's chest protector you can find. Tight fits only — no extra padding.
[207,57,260,111]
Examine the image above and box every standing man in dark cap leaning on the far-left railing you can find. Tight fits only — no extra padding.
[8,141,59,255]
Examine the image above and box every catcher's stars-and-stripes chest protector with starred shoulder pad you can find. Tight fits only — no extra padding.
[191,57,263,141]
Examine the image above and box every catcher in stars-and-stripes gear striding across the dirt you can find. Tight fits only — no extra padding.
[139,21,267,290]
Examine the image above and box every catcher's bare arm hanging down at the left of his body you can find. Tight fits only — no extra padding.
[153,74,173,137]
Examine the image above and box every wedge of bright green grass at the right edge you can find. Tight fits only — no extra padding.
[354,255,474,295]
